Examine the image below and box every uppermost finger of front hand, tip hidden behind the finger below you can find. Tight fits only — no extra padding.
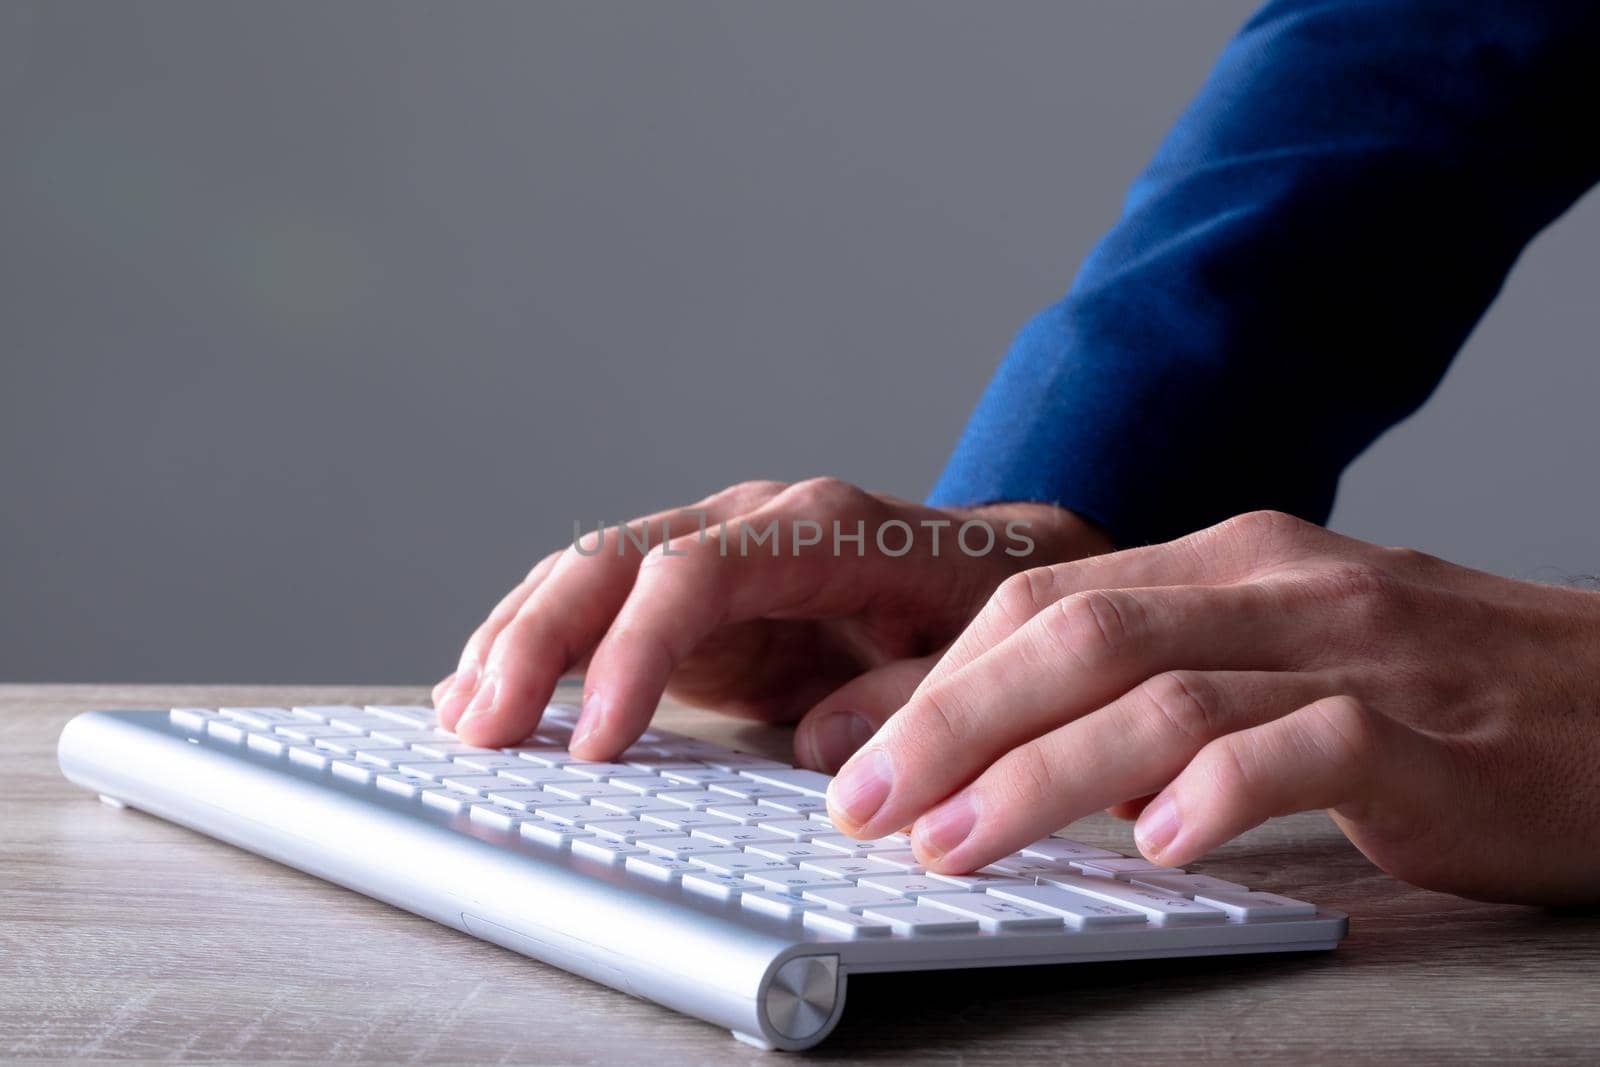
[923,512,1333,686]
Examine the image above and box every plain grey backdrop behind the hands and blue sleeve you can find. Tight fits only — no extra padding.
[0,0,1600,681]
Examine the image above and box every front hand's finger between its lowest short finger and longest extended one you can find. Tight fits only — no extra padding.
[912,670,1334,873]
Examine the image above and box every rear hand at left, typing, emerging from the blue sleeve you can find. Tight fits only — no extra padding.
[434,478,1112,771]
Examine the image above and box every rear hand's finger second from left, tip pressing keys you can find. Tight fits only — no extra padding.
[442,482,781,747]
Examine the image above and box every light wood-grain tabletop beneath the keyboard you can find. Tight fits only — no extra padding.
[0,685,1600,1064]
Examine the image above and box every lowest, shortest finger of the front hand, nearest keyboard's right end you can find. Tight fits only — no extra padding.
[1134,696,1426,867]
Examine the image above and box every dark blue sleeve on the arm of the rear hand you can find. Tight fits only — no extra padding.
[930,0,1600,545]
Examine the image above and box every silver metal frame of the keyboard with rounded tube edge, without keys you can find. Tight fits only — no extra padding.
[59,709,1347,1049]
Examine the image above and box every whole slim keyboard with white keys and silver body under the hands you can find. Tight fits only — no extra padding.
[61,704,1346,1048]
